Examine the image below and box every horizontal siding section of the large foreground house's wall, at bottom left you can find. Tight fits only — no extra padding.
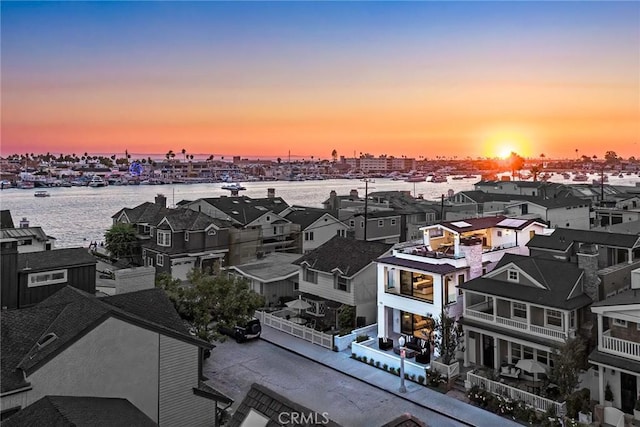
[158,335,215,427]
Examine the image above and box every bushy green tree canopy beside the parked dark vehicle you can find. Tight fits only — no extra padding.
[156,269,264,341]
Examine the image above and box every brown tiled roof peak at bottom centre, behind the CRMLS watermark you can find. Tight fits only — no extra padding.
[227,383,339,427]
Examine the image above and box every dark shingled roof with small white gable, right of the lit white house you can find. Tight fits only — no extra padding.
[458,254,592,310]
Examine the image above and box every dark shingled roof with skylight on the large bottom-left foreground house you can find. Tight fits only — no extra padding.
[0,286,212,392]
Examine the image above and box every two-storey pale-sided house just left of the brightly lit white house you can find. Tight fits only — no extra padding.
[295,236,391,326]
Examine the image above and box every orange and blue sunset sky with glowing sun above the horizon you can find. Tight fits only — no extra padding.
[0,1,640,159]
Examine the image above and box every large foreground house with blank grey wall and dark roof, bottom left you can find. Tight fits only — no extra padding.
[0,286,231,426]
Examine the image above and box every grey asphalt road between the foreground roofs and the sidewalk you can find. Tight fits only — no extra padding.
[204,340,464,427]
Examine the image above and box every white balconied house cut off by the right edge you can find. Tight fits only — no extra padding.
[589,269,640,414]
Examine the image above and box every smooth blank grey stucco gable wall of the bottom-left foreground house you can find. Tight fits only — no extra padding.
[27,318,159,422]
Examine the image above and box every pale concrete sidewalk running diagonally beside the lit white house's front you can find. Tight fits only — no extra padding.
[261,326,520,427]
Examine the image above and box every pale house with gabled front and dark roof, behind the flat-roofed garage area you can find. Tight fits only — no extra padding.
[281,206,349,254]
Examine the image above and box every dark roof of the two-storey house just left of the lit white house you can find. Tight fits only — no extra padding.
[294,236,393,277]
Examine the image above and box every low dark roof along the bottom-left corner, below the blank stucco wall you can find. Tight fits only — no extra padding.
[2,396,158,427]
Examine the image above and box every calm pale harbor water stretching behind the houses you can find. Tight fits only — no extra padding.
[0,176,640,248]
